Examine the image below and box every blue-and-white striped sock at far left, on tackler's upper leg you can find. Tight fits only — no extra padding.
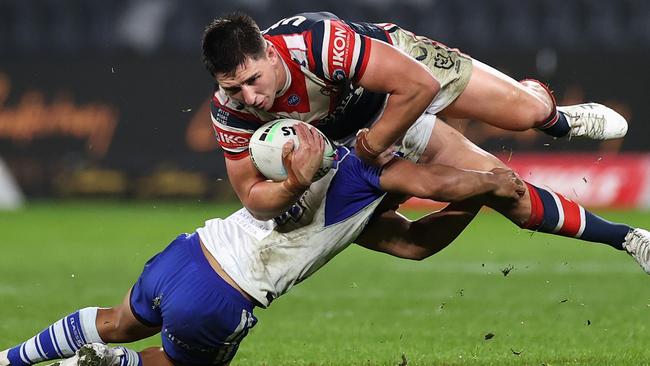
[7,307,104,366]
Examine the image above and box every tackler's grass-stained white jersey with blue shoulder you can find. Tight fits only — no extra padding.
[197,147,384,307]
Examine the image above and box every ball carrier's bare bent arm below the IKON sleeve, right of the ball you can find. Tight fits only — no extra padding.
[357,39,440,161]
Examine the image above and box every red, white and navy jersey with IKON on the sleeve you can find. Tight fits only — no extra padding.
[211,13,396,159]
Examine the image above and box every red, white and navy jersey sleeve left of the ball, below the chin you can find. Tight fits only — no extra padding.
[210,92,262,160]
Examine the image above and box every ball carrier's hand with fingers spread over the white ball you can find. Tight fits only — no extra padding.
[282,123,325,193]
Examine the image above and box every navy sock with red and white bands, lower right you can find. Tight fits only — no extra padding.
[522,182,632,250]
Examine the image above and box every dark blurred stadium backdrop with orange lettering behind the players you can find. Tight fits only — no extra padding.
[0,0,650,197]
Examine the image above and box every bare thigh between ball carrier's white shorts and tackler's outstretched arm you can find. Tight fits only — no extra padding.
[418,119,507,171]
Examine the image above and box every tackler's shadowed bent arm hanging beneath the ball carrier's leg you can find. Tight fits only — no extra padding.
[356,201,481,260]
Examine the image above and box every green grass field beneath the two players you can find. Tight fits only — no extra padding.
[0,202,650,365]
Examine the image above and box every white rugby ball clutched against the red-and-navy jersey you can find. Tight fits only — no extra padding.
[248,118,336,182]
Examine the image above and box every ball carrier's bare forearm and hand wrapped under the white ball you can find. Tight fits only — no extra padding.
[226,125,325,220]
